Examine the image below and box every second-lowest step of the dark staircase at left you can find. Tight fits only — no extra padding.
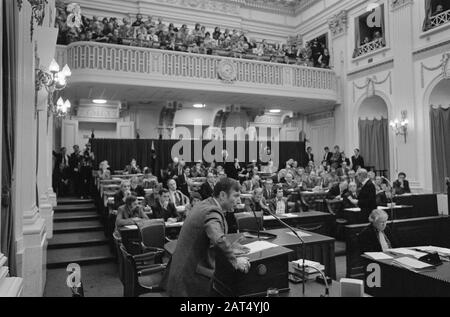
[48,231,108,250]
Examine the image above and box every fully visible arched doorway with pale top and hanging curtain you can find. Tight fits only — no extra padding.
[358,95,389,176]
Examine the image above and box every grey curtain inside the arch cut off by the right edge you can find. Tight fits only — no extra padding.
[430,108,450,193]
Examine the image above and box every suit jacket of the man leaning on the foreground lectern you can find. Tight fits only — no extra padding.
[164,198,236,297]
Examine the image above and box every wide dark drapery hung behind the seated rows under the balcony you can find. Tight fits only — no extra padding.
[91,139,305,173]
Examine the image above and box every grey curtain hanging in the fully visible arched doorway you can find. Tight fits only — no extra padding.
[358,118,389,171]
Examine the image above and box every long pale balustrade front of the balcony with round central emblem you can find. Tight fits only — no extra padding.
[56,42,336,97]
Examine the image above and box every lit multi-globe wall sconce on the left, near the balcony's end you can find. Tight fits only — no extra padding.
[35,59,72,117]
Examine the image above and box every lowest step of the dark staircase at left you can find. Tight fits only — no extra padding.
[47,246,114,269]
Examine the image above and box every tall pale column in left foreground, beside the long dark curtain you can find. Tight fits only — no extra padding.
[13,1,47,296]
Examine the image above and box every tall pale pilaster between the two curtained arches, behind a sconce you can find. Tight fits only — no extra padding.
[389,0,416,180]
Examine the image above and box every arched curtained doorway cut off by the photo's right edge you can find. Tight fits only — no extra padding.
[429,79,450,193]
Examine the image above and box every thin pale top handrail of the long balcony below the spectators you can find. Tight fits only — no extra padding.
[58,41,335,75]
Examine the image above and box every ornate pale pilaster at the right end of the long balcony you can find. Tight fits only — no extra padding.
[328,10,350,153]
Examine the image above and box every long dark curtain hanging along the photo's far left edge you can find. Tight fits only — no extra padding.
[0,1,18,276]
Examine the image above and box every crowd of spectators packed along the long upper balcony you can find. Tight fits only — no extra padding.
[56,10,330,68]
